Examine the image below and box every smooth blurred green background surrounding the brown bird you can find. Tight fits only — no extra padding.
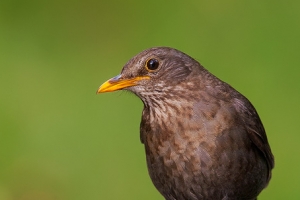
[0,0,300,200]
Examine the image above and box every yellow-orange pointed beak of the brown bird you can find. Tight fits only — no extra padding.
[97,75,150,94]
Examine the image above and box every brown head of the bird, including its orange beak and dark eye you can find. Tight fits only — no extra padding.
[97,47,200,100]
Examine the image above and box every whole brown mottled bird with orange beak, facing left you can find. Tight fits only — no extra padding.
[97,47,274,200]
